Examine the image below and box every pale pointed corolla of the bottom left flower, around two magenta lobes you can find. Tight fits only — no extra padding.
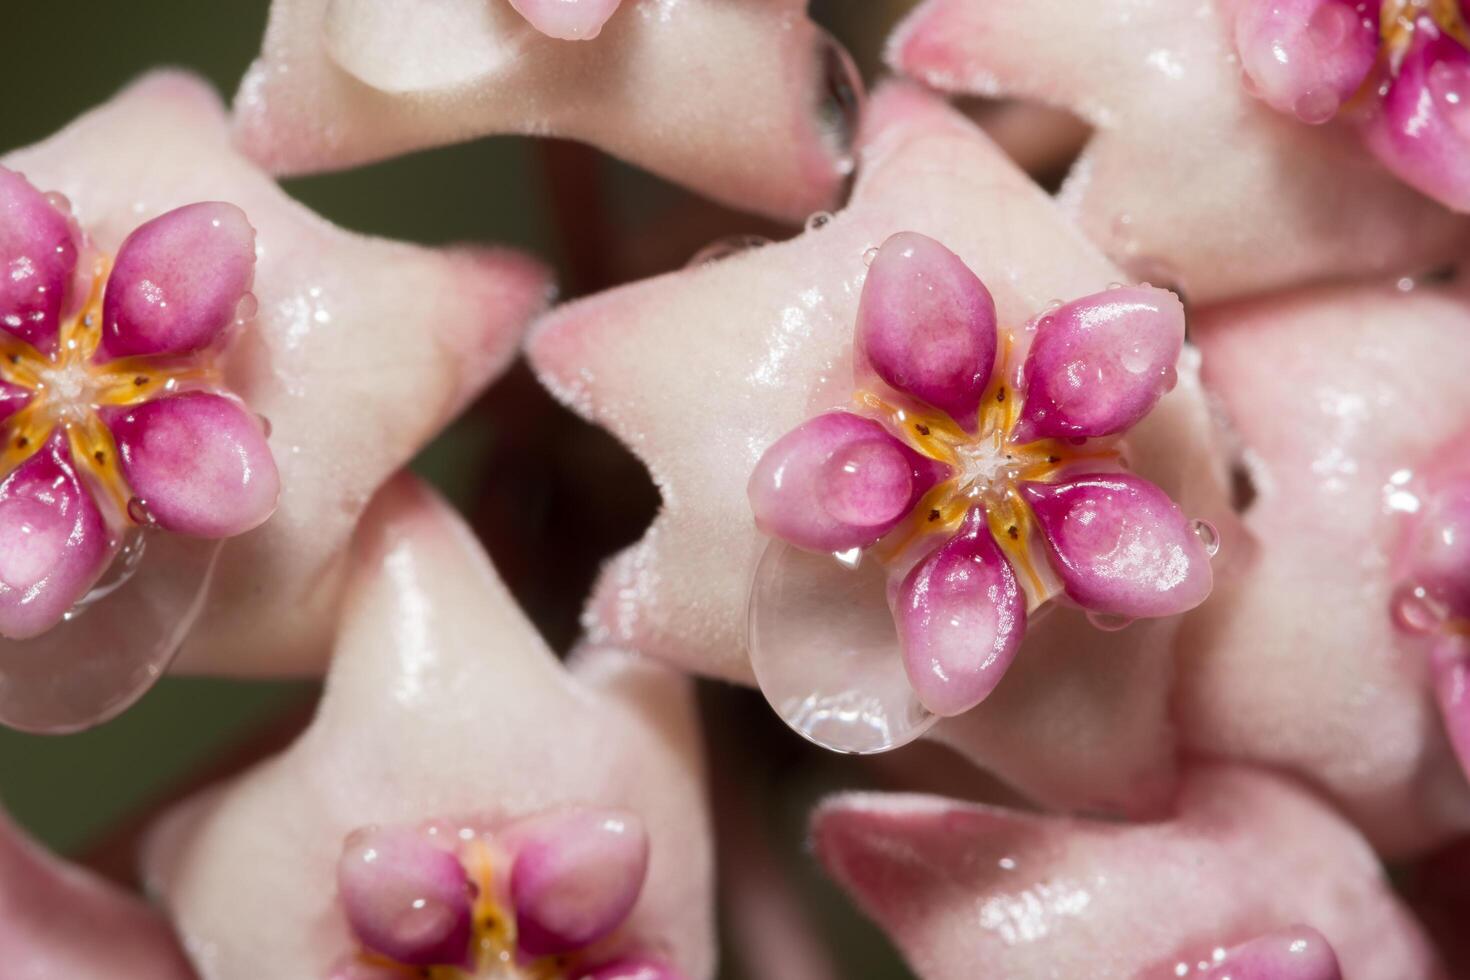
[146,478,713,980]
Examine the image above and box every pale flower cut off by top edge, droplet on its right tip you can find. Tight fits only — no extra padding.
[235,0,863,220]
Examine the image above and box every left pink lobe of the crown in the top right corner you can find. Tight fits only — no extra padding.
[1235,0,1379,123]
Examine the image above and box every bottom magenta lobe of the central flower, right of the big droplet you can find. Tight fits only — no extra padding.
[894,507,1026,716]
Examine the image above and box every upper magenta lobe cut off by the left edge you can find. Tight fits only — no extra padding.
[0,166,76,353]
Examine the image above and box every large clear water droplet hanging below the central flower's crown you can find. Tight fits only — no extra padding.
[750,541,938,754]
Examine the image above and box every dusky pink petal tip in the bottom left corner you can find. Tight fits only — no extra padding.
[0,814,194,980]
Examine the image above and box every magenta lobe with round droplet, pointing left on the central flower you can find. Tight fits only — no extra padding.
[747,411,947,551]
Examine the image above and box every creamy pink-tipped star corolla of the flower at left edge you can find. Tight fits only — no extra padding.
[0,72,548,674]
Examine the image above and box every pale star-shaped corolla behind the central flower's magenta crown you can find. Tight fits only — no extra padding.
[529,85,1236,813]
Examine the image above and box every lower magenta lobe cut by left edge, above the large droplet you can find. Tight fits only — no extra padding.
[0,429,112,639]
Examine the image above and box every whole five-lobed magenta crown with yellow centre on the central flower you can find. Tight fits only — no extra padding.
[750,232,1216,734]
